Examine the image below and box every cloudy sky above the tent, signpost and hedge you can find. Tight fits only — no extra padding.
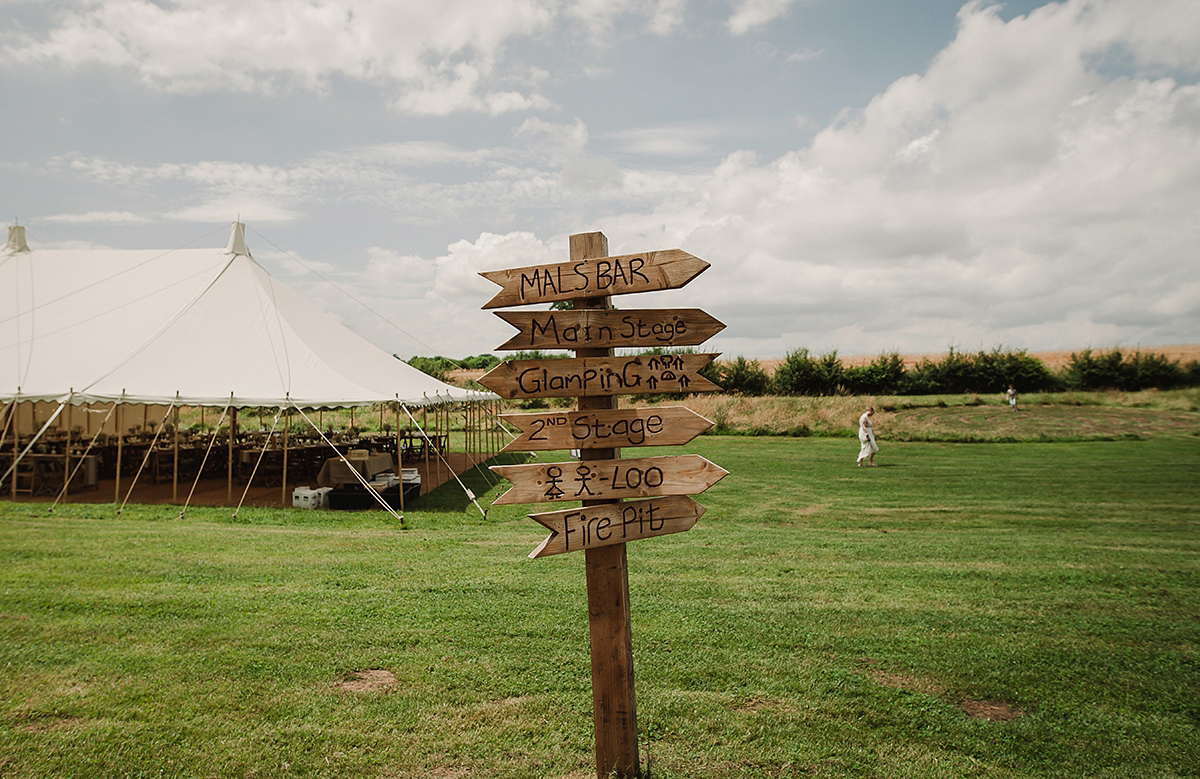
[0,0,1200,358]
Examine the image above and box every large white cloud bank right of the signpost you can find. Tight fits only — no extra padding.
[576,0,1200,355]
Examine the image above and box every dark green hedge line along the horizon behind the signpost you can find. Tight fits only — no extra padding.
[397,348,1200,395]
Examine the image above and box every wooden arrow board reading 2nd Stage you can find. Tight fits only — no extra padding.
[500,406,713,451]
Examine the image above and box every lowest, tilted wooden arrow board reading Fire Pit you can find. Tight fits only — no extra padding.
[529,495,704,557]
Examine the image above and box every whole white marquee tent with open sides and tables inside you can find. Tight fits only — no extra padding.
[0,223,504,511]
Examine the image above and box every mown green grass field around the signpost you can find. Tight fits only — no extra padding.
[0,407,1200,779]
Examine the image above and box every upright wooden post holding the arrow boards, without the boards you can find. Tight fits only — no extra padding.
[570,233,641,779]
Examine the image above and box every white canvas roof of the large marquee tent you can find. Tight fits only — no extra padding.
[0,223,477,407]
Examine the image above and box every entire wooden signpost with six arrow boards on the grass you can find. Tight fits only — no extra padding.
[479,233,727,779]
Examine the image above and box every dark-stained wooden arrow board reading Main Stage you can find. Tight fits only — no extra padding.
[496,308,725,350]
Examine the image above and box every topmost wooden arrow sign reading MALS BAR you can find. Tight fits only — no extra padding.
[480,248,708,308]
